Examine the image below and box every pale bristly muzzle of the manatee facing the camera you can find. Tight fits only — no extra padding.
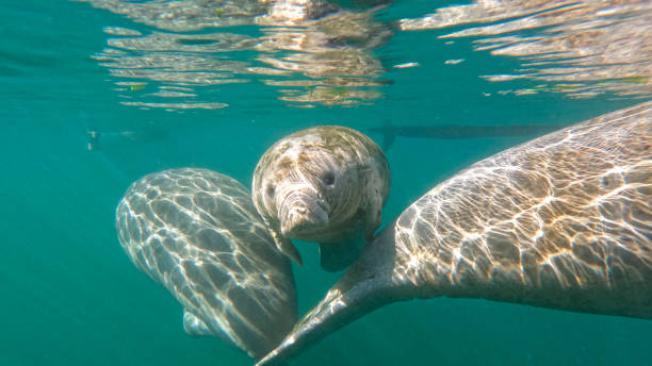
[280,199,329,240]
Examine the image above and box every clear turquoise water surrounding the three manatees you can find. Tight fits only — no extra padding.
[0,0,652,366]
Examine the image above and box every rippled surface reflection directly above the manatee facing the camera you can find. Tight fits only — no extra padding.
[79,0,391,109]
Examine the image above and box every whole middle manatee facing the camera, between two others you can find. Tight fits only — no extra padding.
[252,126,390,271]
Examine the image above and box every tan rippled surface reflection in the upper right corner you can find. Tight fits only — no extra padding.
[399,0,652,98]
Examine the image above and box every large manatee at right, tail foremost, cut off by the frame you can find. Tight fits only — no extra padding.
[258,103,652,365]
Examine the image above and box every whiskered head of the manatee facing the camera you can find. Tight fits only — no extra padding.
[253,127,372,242]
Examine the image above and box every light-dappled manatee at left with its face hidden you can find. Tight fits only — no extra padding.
[116,169,296,358]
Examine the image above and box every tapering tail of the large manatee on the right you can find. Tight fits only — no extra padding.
[256,229,407,366]
